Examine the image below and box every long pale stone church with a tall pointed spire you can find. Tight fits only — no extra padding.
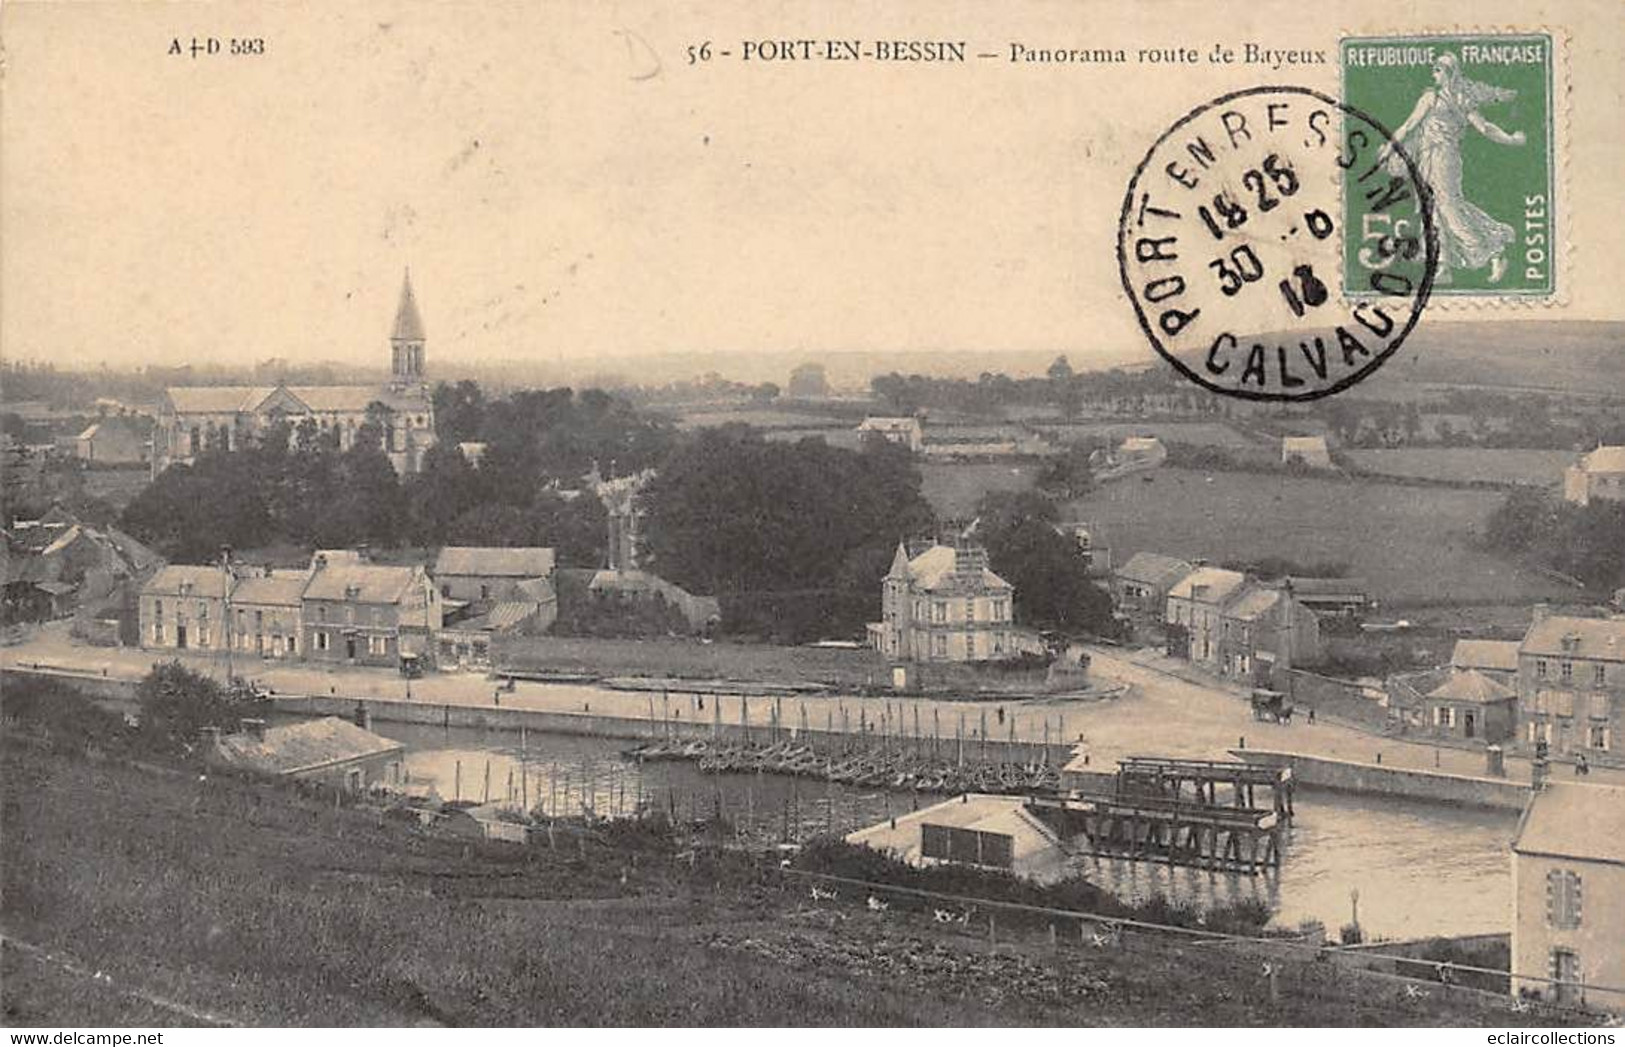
[153,272,434,478]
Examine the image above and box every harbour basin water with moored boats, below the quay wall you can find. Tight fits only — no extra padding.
[374,723,1518,938]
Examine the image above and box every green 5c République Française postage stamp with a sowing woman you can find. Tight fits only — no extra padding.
[1342,33,1560,299]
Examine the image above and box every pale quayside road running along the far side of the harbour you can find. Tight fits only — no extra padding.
[9,624,1625,785]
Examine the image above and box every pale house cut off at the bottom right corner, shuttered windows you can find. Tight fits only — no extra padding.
[1511,782,1625,1014]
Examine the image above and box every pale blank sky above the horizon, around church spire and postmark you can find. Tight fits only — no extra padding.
[0,0,1625,374]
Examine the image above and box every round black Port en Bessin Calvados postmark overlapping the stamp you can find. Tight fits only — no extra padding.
[1118,86,1438,400]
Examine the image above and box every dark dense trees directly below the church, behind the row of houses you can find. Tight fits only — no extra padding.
[124,382,673,567]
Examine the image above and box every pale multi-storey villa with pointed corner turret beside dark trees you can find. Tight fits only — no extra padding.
[868,543,1022,662]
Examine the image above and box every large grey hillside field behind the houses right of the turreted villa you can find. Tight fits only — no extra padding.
[1073,468,1573,606]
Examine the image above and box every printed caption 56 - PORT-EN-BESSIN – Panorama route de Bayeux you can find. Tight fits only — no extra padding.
[687,37,1331,70]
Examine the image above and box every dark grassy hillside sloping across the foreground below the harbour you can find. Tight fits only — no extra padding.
[0,738,1553,1027]
